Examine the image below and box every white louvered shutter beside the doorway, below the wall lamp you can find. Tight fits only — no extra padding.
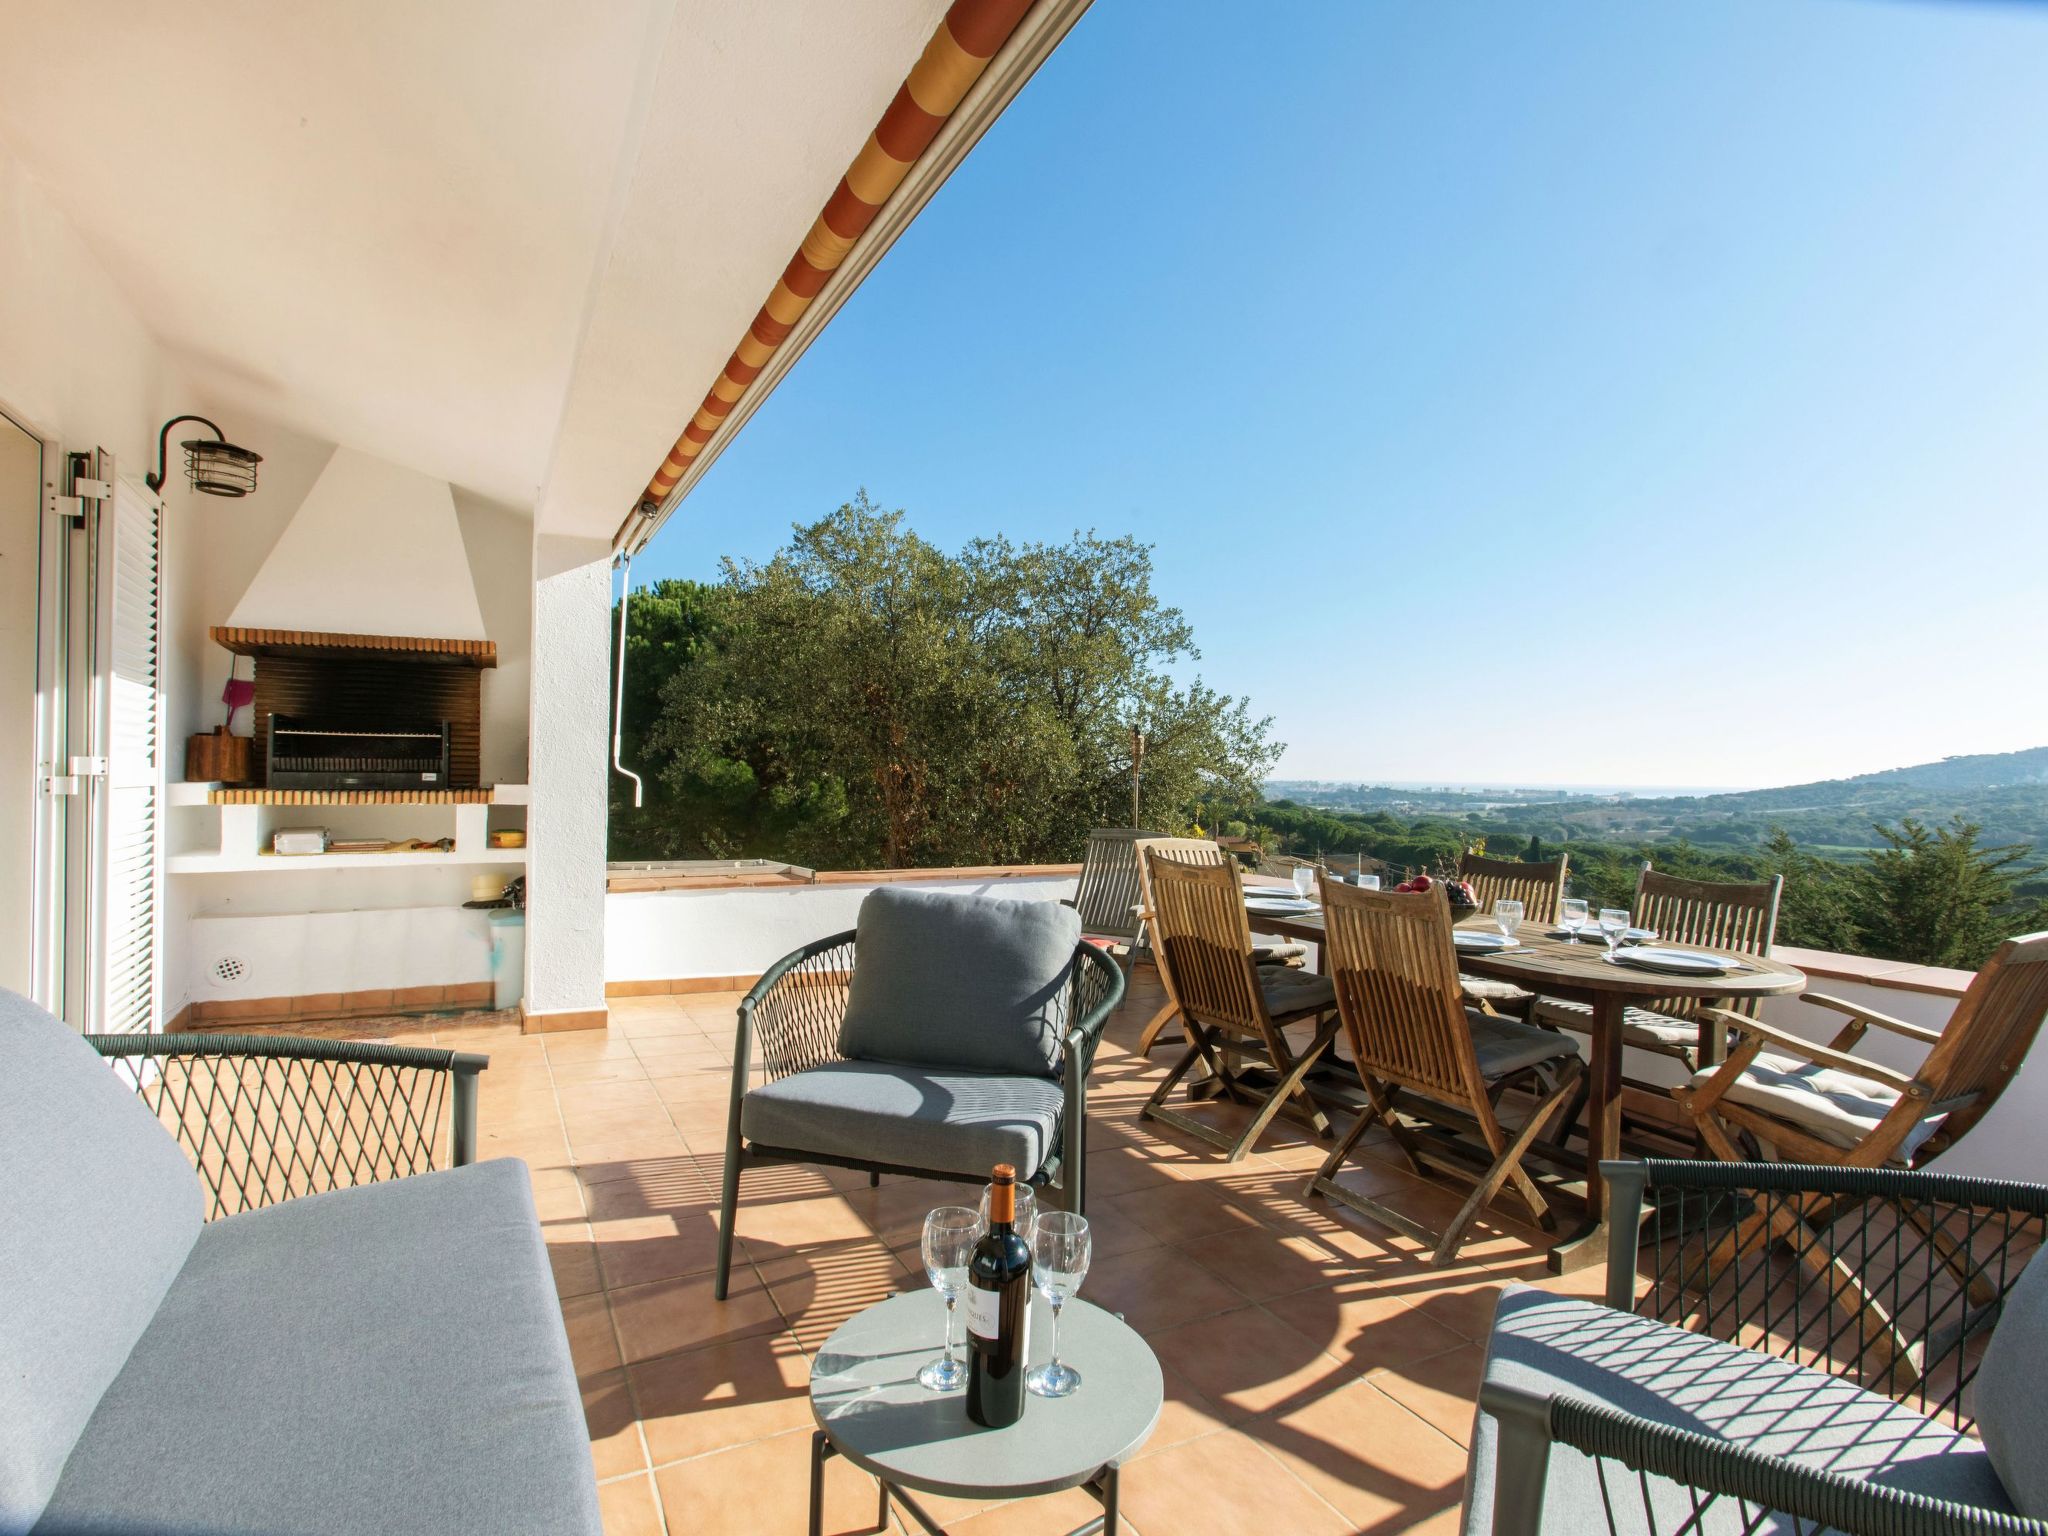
[92,479,164,1034]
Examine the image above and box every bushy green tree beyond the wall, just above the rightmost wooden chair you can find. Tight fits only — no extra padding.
[1855,815,2044,971]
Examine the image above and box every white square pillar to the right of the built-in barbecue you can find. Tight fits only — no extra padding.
[524,535,612,1032]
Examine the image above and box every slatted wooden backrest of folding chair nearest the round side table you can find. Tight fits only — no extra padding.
[1323,881,1491,1120]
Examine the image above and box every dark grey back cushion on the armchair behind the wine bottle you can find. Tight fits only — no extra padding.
[840,887,1081,1075]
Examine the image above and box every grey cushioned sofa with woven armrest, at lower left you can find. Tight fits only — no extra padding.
[0,991,600,1536]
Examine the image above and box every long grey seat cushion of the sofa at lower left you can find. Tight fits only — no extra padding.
[35,1161,600,1536]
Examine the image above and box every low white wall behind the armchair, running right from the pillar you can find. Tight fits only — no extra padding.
[604,877,1075,983]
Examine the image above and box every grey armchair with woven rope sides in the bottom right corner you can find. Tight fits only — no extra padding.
[1464,1161,2048,1536]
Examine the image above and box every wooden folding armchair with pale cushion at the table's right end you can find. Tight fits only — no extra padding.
[1671,934,2048,1382]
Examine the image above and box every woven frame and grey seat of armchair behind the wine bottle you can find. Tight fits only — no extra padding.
[715,930,1124,1300]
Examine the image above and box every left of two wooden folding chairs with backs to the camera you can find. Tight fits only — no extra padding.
[1141,848,1337,1163]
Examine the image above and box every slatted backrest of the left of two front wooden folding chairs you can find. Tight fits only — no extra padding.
[1145,844,1272,1038]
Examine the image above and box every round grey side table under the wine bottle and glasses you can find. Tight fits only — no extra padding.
[811,1290,1165,1536]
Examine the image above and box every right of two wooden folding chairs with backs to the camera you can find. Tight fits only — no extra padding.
[1309,883,1585,1266]
